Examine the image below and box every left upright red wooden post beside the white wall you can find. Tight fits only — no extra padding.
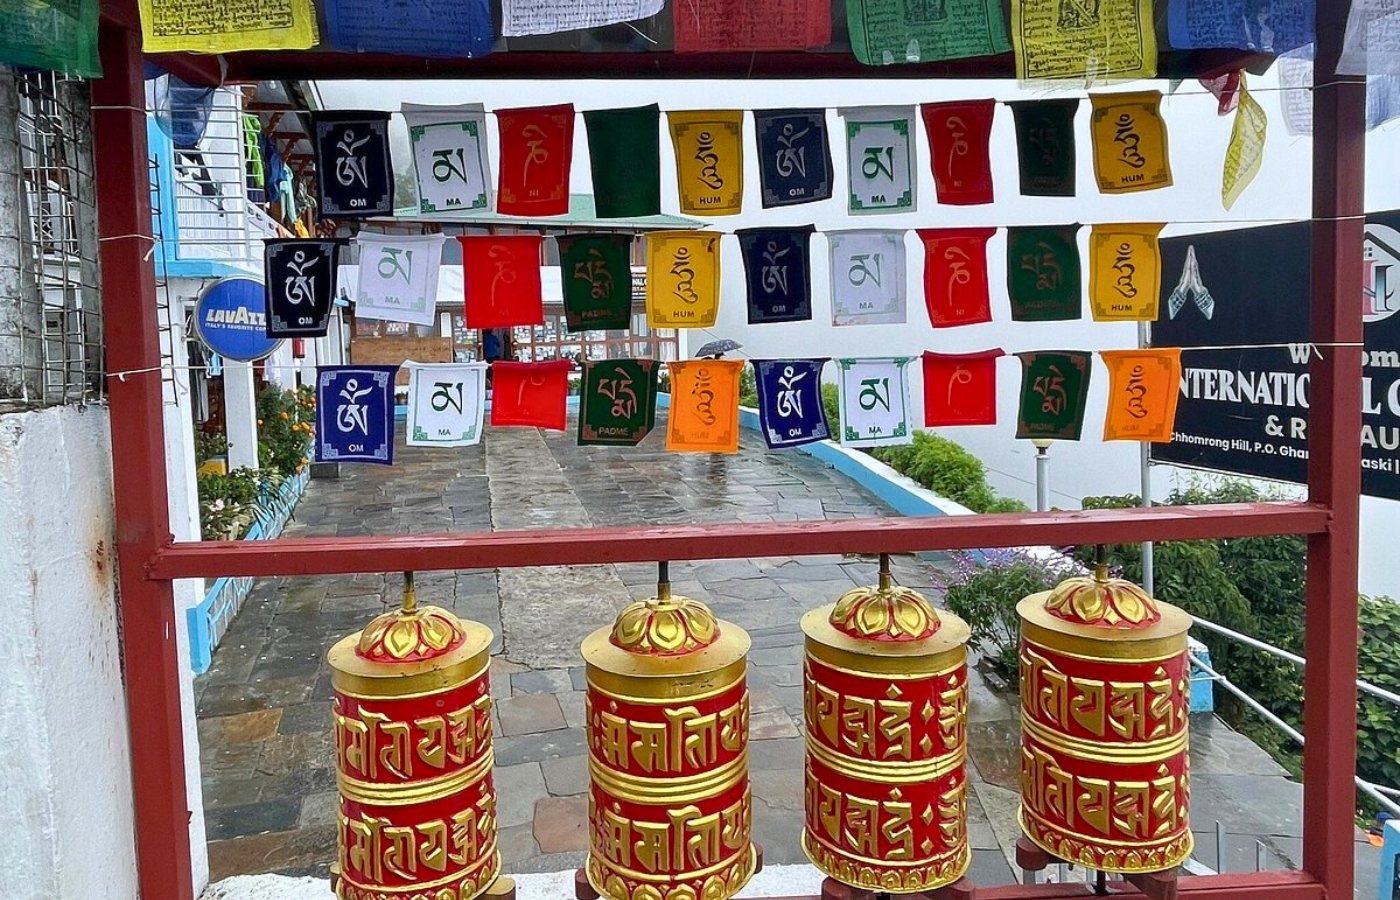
[92,19,195,900]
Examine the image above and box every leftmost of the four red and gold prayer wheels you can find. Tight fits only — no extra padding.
[328,572,514,900]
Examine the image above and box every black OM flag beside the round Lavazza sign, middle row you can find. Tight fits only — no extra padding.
[263,239,340,337]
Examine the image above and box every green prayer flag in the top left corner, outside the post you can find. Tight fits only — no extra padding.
[0,0,102,78]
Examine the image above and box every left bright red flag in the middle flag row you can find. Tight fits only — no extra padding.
[458,234,545,329]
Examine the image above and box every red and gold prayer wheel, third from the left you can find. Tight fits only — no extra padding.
[802,556,972,893]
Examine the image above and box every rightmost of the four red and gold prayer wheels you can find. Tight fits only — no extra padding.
[1016,561,1191,875]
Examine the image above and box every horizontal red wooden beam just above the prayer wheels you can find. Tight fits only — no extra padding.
[147,502,1330,579]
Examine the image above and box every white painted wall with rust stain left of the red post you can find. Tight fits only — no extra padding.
[0,406,136,900]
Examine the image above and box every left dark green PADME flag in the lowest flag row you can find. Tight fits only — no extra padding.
[578,360,659,447]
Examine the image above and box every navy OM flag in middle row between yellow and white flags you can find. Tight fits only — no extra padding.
[738,225,813,325]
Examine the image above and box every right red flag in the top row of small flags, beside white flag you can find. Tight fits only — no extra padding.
[920,99,997,206]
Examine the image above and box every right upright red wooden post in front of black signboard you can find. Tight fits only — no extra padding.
[1303,0,1366,900]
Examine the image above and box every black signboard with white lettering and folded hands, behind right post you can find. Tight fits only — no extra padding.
[1152,211,1400,500]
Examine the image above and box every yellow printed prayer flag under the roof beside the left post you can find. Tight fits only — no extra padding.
[137,0,318,53]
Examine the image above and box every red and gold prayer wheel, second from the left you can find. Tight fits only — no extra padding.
[582,581,756,900]
